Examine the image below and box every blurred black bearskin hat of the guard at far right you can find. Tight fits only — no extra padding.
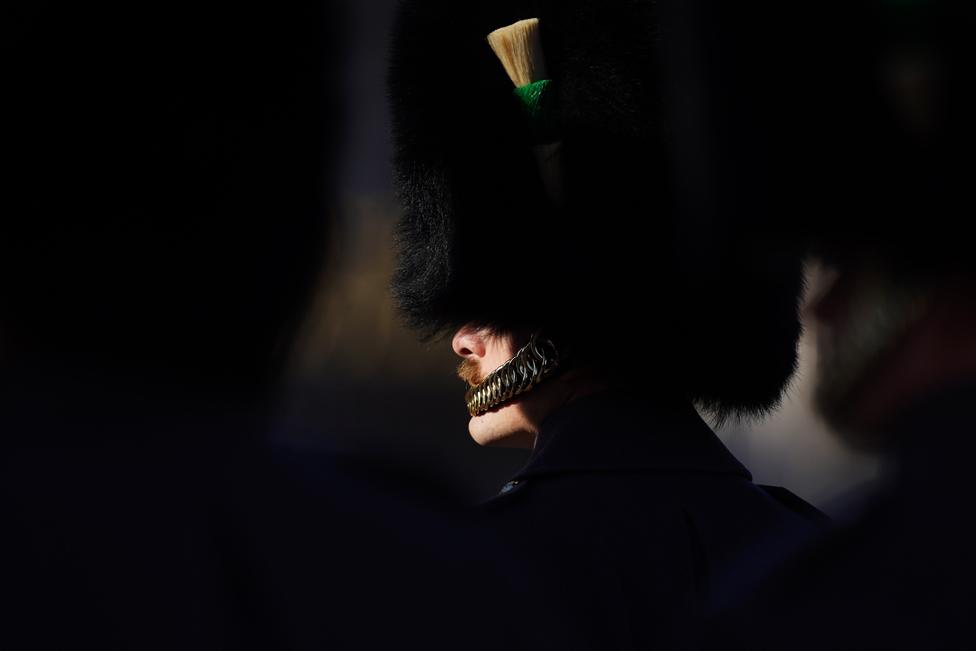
[809,0,976,276]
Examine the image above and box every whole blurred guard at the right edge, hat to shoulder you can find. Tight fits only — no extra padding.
[711,2,976,649]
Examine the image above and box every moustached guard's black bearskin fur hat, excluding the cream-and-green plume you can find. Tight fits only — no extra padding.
[389,0,800,418]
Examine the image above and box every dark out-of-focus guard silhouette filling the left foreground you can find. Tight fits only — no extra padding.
[0,2,510,650]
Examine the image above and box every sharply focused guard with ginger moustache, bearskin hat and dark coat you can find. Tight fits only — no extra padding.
[389,0,820,648]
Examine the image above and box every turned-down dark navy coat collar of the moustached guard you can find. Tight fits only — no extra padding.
[515,391,752,480]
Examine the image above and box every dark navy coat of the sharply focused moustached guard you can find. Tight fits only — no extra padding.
[481,392,823,649]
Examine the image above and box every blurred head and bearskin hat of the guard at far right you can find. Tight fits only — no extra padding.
[809,3,976,450]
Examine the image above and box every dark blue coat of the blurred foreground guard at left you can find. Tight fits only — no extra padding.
[0,413,517,651]
